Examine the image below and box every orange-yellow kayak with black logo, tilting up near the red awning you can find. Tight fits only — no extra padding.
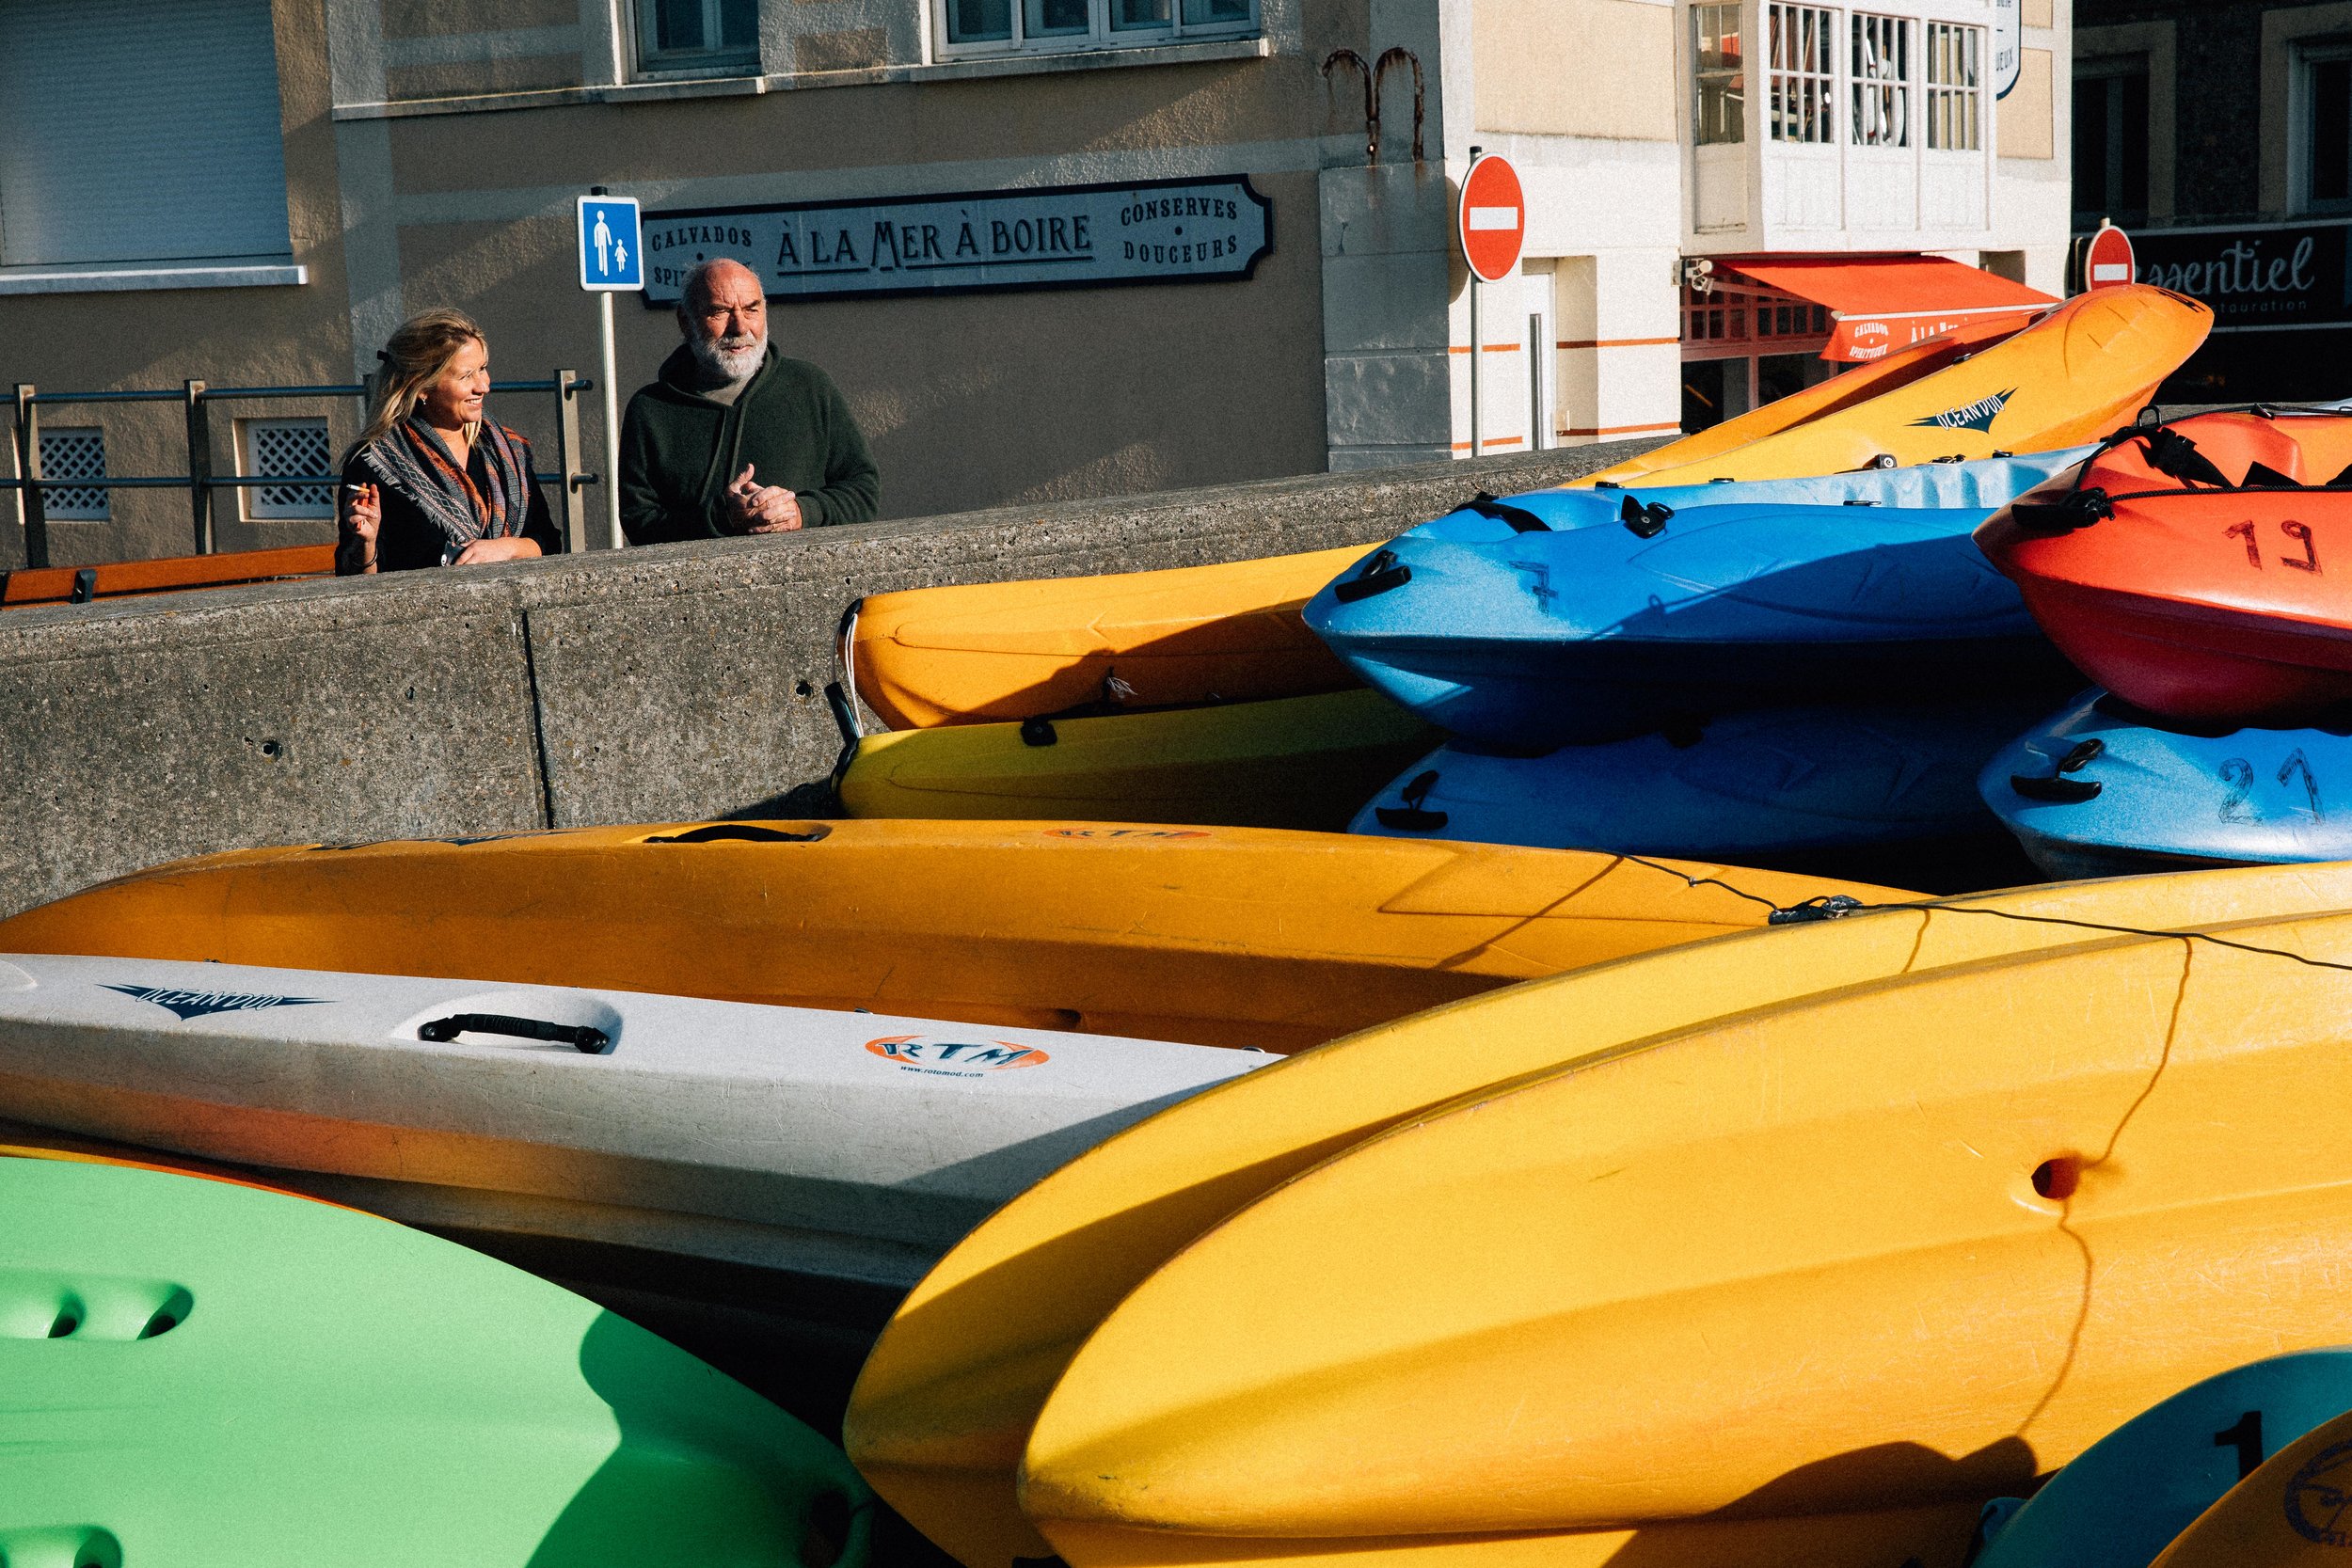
[1642,284,2214,484]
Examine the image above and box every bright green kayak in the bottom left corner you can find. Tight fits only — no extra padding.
[0,1159,870,1568]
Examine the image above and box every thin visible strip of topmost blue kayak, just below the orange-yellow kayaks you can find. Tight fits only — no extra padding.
[1409,447,2098,546]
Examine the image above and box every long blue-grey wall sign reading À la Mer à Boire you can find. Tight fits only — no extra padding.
[644,176,1275,306]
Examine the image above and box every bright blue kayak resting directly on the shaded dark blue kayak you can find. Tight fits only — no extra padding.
[1306,505,2063,748]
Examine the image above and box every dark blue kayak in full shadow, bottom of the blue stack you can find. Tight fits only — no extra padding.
[1348,696,2042,865]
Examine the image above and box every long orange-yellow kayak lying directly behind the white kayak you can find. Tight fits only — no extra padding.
[0,820,1908,1051]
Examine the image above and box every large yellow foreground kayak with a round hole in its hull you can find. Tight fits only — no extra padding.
[1021,893,2352,1568]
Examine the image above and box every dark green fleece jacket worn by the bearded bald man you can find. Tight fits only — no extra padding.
[621,345,882,546]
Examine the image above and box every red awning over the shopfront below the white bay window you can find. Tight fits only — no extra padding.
[1715,256,2058,359]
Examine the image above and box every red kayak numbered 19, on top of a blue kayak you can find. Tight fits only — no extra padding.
[1976,409,2352,724]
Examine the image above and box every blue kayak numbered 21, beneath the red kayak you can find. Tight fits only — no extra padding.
[1979,691,2352,877]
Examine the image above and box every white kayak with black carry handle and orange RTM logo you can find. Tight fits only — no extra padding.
[0,955,1279,1293]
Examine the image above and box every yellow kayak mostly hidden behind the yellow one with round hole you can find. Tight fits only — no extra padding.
[845,865,2352,1568]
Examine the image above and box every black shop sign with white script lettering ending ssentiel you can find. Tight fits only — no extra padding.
[2131,223,2352,331]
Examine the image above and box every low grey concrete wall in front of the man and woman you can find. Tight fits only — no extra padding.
[0,432,1642,912]
